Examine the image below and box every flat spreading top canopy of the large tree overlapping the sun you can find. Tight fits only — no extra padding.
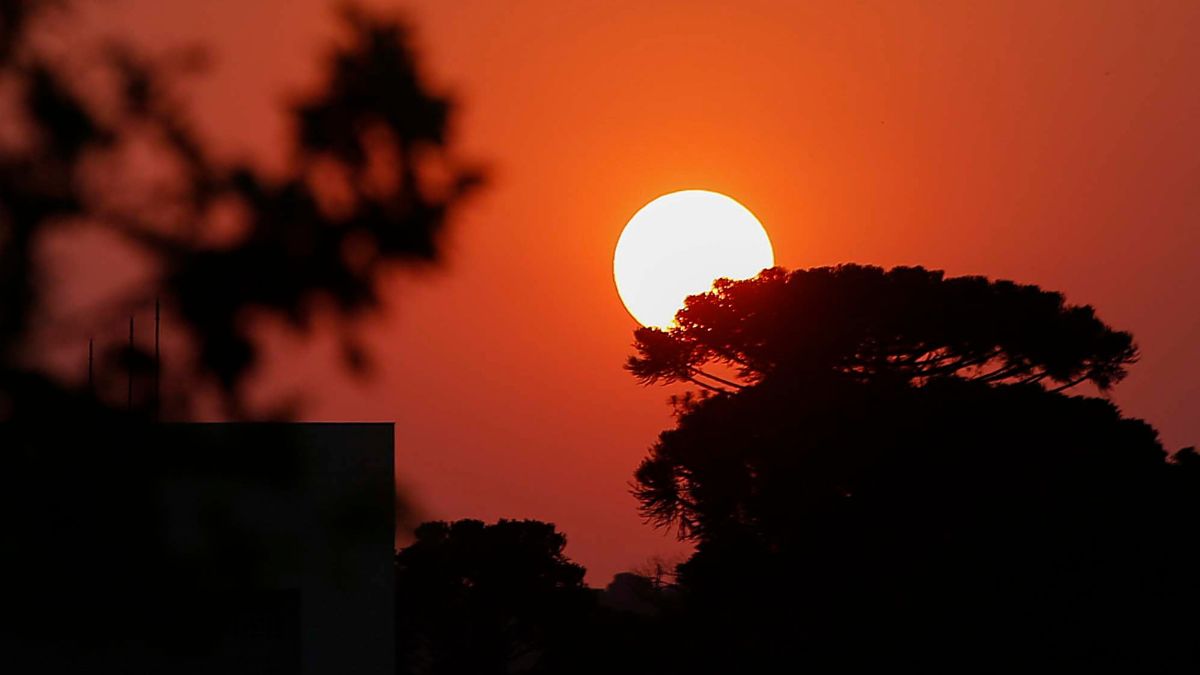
[628,264,1138,390]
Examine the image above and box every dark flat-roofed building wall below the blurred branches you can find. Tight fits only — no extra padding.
[0,423,396,675]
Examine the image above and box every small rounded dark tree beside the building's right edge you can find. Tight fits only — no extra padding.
[396,520,594,675]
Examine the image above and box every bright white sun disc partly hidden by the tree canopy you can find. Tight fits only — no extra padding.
[612,190,775,328]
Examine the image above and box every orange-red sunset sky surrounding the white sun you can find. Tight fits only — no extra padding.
[92,0,1200,584]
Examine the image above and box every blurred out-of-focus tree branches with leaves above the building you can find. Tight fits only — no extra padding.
[0,0,479,419]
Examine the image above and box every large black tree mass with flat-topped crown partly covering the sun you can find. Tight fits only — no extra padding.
[629,265,1200,670]
